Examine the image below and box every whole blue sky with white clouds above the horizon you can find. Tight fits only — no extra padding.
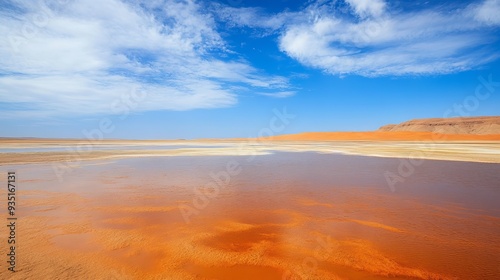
[0,0,500,139]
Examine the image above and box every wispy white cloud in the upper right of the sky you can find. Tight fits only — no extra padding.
[279,0,498,76]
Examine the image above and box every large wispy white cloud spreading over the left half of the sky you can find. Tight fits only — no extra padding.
[0,0,288,117]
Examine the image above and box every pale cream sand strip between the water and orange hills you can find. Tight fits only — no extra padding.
[0,139,500,165]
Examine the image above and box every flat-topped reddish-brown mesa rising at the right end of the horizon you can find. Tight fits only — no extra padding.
[378,116,500,135]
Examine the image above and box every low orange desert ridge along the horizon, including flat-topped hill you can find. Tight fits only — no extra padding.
[0,116,500,143]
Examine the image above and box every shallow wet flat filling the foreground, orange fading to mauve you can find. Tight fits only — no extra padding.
[0,151,500,280]
